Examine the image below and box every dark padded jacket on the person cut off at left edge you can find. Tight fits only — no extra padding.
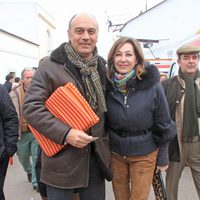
[0,85,18,158]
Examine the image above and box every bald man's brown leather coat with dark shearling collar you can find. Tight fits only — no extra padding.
[23,44,111,189]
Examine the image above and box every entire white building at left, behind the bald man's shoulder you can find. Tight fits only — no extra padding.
[0,1,55,83]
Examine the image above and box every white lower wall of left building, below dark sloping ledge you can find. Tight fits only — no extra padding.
[0,31,39,83]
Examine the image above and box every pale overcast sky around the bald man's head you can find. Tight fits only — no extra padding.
[41,0,163,57]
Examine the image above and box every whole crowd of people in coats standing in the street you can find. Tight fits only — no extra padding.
[0,13,200,200]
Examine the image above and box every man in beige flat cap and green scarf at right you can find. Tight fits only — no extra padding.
[162,45,200,200]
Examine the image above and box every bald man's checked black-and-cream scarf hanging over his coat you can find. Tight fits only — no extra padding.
[64,43,107,114]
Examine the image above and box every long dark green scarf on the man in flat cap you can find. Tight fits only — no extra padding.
[179,69,200,142]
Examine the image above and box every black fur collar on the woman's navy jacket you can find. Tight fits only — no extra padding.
[107,65,160,91]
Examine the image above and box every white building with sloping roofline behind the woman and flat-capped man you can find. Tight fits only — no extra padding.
[120,0,200,58]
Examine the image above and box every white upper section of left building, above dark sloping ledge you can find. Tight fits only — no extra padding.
[0,2,39,43]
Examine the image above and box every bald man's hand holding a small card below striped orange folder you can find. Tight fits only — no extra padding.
[66,128,93,148]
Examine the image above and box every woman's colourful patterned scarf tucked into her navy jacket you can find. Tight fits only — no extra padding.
[113,69,135,94]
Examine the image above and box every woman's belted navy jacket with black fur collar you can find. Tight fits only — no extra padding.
[106,65,175,165]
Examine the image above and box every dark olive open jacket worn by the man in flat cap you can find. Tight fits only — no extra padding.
[162,76,185,162]
